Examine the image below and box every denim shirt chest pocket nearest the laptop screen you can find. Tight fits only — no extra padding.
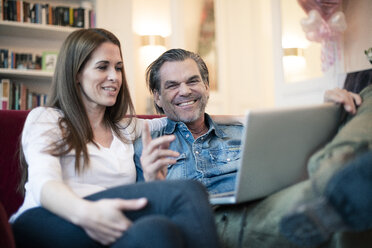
[209,146,241,175]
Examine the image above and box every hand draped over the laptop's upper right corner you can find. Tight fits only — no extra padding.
[324,88,362,114]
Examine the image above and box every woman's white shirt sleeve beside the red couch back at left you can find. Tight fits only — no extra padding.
[22,107,62,205]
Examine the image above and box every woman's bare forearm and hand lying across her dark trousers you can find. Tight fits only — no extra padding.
[40,180,147,245]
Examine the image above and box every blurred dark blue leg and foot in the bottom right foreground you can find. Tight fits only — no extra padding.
[280,151,372,247]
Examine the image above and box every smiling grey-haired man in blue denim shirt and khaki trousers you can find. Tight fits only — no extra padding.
[135,49,365,247]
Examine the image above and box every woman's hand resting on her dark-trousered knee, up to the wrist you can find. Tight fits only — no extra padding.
[75,198,147,245]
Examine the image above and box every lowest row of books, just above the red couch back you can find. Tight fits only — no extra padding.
[0,78,47,110]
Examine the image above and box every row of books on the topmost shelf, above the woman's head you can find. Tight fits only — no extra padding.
[0,0,95,28]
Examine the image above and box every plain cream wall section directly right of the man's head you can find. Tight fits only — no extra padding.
[207,0,274,114]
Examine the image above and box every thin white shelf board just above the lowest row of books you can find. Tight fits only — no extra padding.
[0,69,53,81]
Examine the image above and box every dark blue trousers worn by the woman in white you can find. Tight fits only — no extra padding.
[12,180,219,248]
